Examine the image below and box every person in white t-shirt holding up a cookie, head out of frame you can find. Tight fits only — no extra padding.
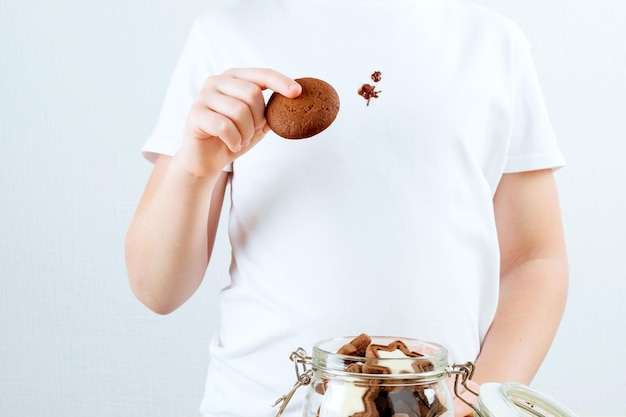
[126,0,568,417]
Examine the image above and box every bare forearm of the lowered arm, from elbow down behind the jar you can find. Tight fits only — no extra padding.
[474,256,568,384]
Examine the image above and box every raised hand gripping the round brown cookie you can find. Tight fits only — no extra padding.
[177,68,302,177]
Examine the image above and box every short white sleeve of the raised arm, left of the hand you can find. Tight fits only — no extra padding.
[141,21,213,162]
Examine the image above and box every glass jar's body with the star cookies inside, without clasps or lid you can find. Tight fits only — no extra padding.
[304,334,454,417]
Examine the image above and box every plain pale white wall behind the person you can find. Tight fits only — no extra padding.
[0,0,626,417]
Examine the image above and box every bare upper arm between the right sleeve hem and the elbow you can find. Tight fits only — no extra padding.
[494,169,566,276]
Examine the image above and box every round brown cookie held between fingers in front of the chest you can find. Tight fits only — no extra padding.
[265,78,339,139]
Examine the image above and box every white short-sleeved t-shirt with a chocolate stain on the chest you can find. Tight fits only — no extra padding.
[143,0,563,417]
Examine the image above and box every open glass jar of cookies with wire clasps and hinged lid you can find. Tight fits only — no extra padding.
[274,336,577,417]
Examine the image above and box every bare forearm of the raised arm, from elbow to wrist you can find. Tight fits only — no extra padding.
[126,158,218,313]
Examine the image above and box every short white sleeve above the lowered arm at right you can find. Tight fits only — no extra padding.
[504,38,565,173]
